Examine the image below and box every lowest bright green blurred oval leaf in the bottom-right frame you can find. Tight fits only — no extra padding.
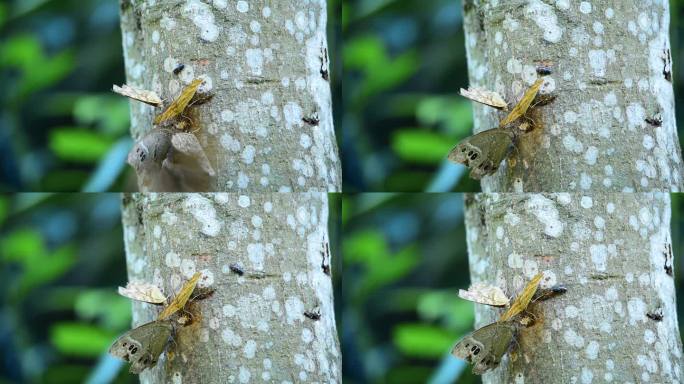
[392,324,456,359]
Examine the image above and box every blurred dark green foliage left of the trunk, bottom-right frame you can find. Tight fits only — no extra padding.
[341,193,477,383]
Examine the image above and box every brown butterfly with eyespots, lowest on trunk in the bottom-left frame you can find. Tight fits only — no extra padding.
[109,320,173,374]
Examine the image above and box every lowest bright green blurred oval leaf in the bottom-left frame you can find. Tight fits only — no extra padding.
[50,323,116,357]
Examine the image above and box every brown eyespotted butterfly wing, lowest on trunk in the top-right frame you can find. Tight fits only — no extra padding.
[448,128,513,180]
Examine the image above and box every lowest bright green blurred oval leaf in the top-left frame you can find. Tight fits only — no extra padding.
[50,127,112,163]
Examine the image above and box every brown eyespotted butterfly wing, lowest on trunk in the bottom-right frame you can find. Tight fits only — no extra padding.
[451,322,516,375]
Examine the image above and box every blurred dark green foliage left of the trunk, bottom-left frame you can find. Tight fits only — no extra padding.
[0,194,137,383]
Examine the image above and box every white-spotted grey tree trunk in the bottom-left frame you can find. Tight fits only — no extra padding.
[123,193,342,383]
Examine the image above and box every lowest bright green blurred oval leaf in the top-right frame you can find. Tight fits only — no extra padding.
[392,129,454,164]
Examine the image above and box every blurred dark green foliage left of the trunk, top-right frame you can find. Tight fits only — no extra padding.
[338,0,479,191]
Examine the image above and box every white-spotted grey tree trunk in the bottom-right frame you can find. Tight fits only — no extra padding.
[466,193,682,384]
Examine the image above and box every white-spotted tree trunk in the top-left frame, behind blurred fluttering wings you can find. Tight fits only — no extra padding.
[121,0,341,191]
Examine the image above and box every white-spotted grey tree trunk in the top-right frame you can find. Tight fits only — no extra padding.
[464,0,682,192]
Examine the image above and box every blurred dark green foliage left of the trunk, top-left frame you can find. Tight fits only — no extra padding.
[0,0,139,191]
